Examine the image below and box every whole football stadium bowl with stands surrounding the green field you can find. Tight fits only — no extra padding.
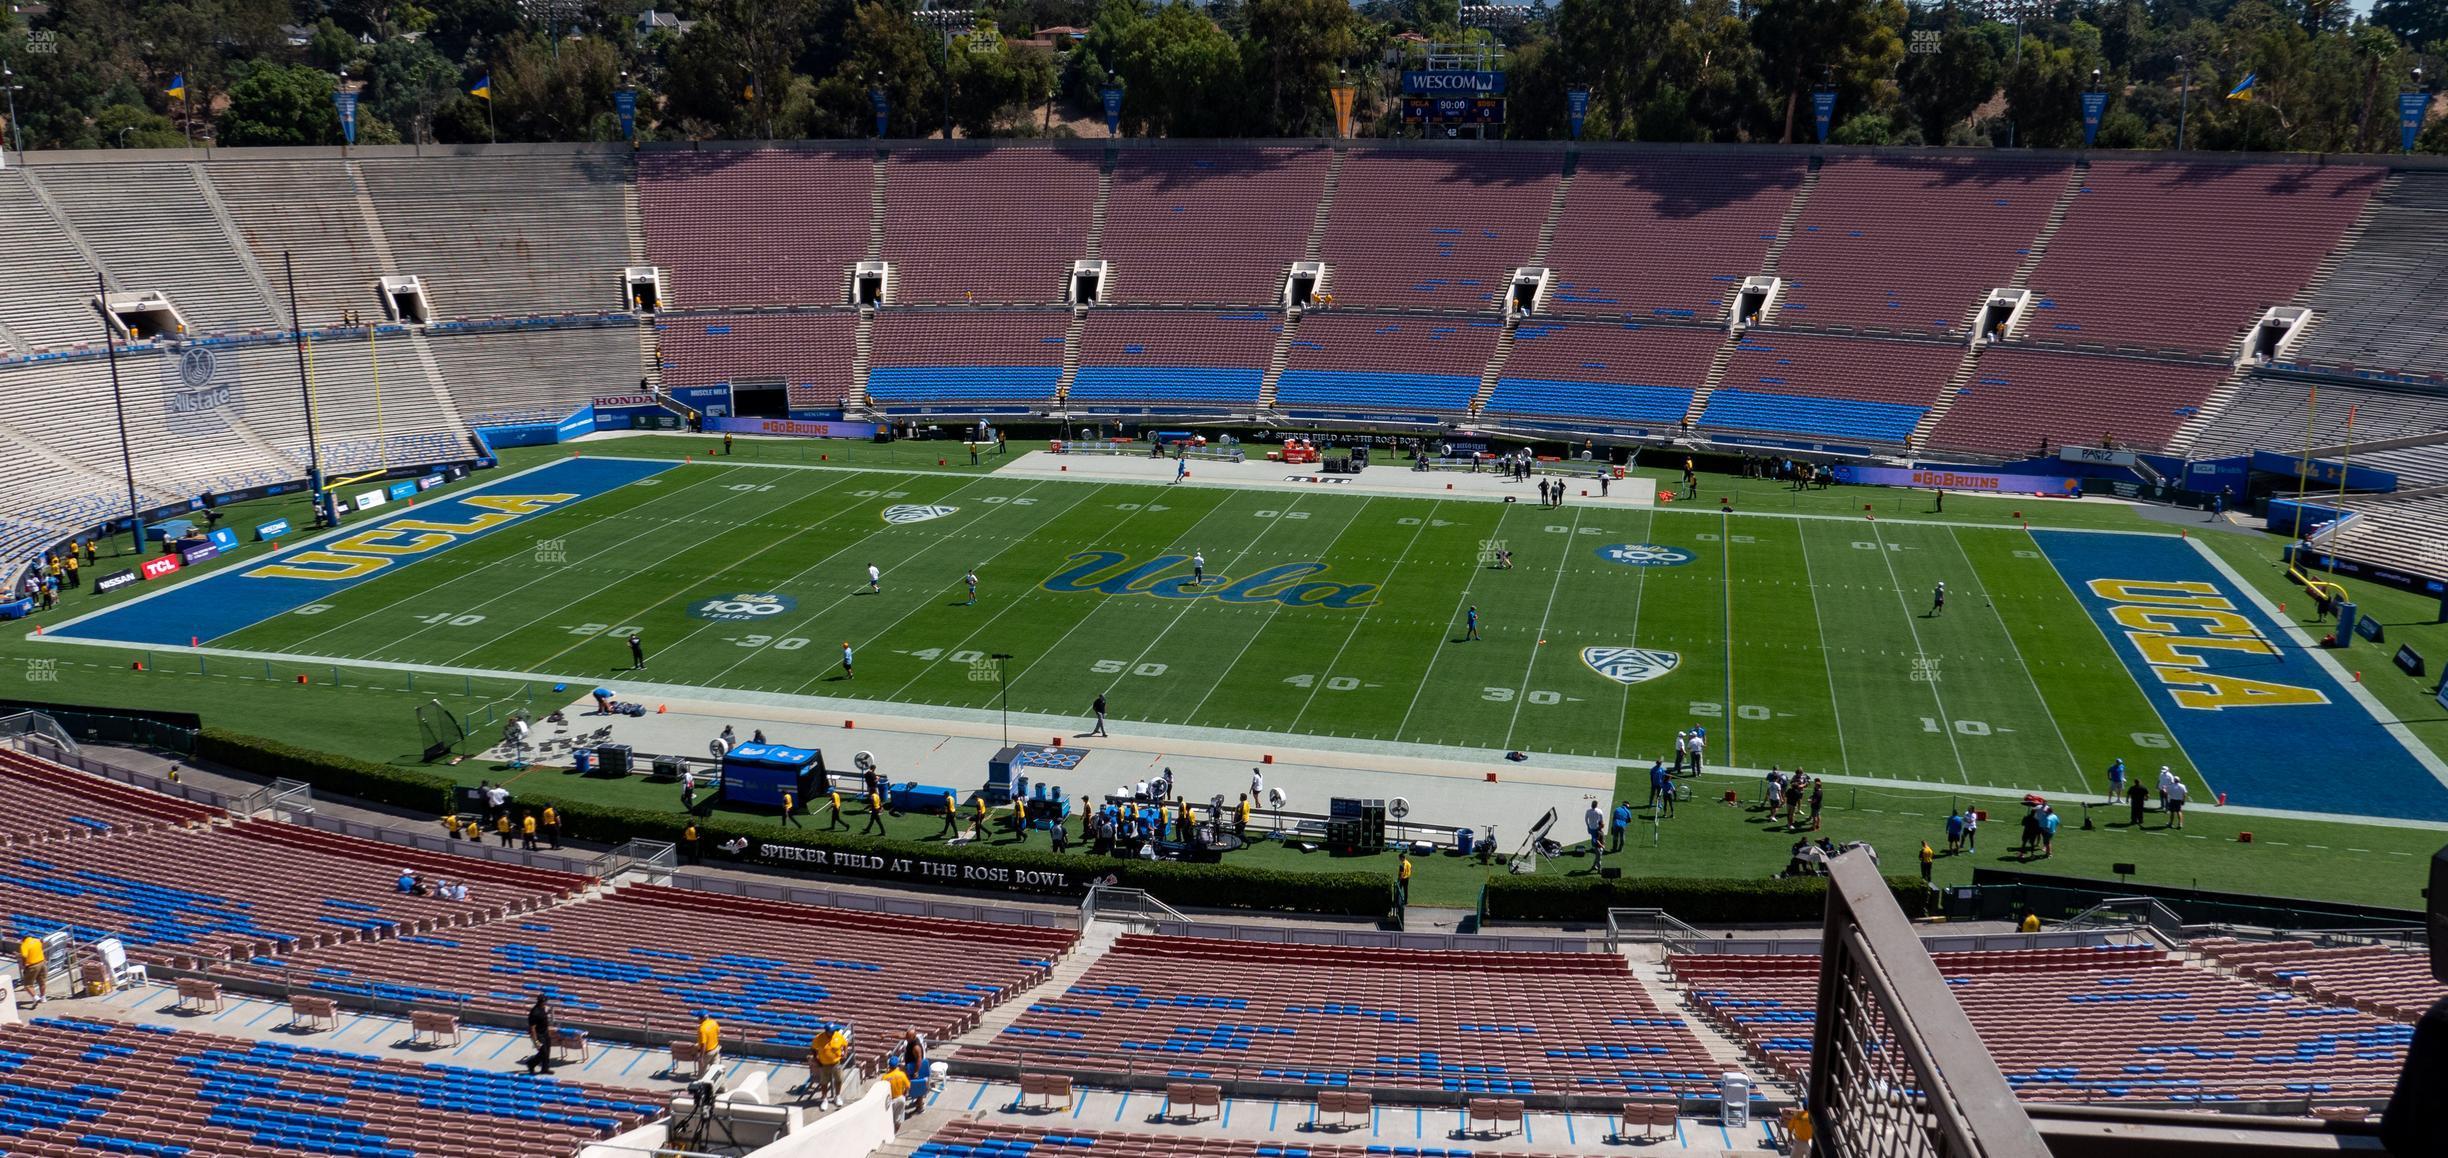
[0,42,2448,1158]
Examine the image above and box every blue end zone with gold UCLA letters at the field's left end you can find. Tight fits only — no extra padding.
[51,458,678,646]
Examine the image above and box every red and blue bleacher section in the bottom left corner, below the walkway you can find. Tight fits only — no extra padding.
[0,1016,663,1158]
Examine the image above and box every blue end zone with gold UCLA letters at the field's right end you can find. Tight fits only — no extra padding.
[2032,531,2448,820]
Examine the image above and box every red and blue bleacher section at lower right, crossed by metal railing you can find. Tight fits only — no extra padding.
[1670,947,2414,1104]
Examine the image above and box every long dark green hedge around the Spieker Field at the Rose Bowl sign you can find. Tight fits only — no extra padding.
[196,727,1393,918]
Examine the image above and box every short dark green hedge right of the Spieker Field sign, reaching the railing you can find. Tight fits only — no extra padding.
[1483,876,1931,925]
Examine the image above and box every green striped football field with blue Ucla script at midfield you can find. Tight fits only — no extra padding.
[54,448,2436,815]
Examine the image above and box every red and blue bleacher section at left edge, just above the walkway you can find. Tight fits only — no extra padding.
[0,817,588,967]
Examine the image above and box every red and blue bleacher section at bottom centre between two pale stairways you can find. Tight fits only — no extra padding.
[965,935,1716,1094]
